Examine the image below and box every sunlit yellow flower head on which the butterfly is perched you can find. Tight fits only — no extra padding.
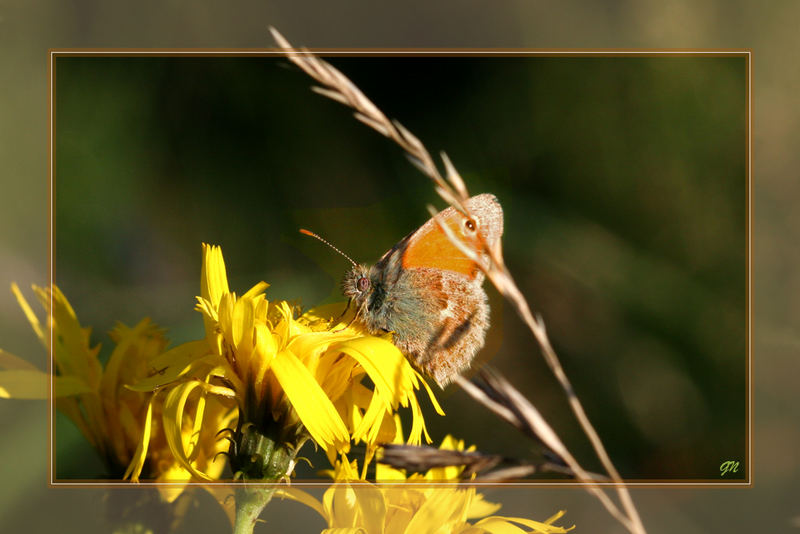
[134,245,441,481]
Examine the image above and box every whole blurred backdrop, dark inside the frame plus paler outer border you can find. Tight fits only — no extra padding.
[0,3,800,532]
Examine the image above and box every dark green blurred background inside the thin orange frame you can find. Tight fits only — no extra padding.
[55,56,747,481]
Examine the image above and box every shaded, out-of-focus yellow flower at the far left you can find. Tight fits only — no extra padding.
[0,285,233,502]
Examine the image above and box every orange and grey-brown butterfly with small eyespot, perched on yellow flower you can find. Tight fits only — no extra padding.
[301,194,503,388]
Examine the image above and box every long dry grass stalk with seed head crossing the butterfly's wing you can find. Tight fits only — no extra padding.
[270,28,645,533]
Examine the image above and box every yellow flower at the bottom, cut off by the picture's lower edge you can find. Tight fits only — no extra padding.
[280,428,570,534]
